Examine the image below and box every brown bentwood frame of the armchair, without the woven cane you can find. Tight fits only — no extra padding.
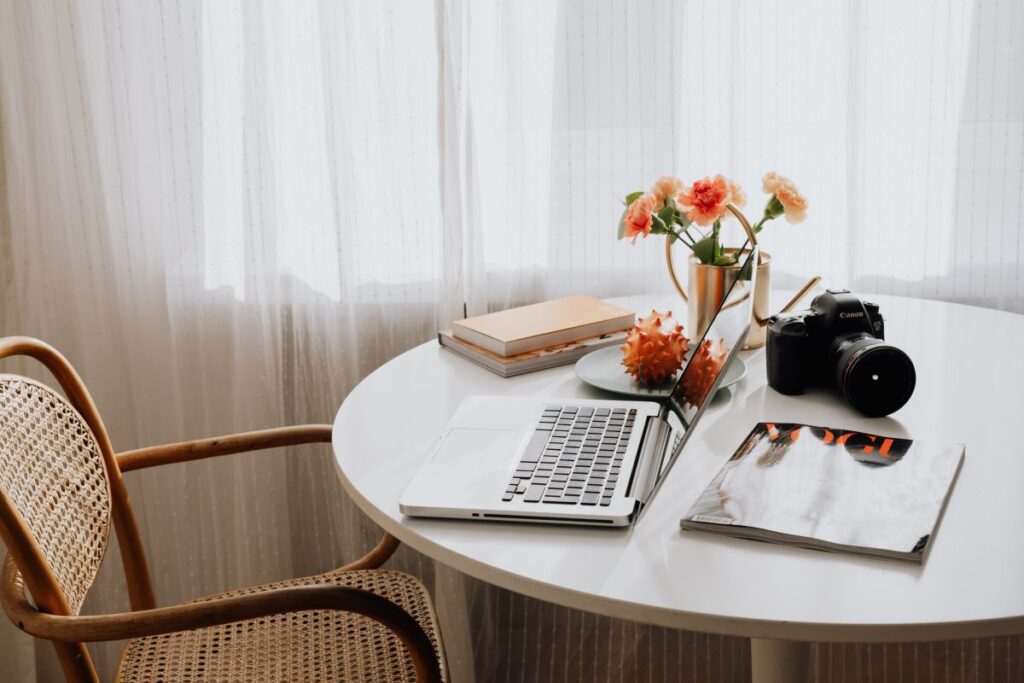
[0,337,442,682]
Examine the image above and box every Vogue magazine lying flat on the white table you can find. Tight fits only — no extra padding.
[680,422,964,562]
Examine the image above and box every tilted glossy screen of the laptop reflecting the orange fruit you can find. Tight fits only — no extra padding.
[643,248,758,502]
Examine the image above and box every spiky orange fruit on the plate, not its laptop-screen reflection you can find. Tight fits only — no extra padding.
[623,310,689,384]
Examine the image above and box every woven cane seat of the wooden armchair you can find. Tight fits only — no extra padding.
[116,569,446,683]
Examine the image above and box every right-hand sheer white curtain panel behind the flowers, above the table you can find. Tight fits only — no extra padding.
[454,0,1024,311]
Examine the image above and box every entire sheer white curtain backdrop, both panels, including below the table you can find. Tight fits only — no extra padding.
[0,0,1024,681]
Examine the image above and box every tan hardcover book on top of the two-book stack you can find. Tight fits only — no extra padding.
[452,296,635,356]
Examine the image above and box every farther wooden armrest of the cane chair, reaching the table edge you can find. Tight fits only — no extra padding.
[117,425,332,472]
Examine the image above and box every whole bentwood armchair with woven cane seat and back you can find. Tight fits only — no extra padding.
[0,337,446,683]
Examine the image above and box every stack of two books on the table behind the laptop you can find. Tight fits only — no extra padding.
[437,296,635,377]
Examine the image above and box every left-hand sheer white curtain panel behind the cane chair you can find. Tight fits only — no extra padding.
[0,1,450,679]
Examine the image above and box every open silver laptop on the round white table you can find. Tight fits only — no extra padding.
[398,249,757,526]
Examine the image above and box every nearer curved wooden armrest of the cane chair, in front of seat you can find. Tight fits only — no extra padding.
[0,556,441,683]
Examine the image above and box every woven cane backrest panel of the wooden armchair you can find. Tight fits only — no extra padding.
[0,375,111,614]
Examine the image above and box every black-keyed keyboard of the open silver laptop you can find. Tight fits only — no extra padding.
[502,405,637,505]
